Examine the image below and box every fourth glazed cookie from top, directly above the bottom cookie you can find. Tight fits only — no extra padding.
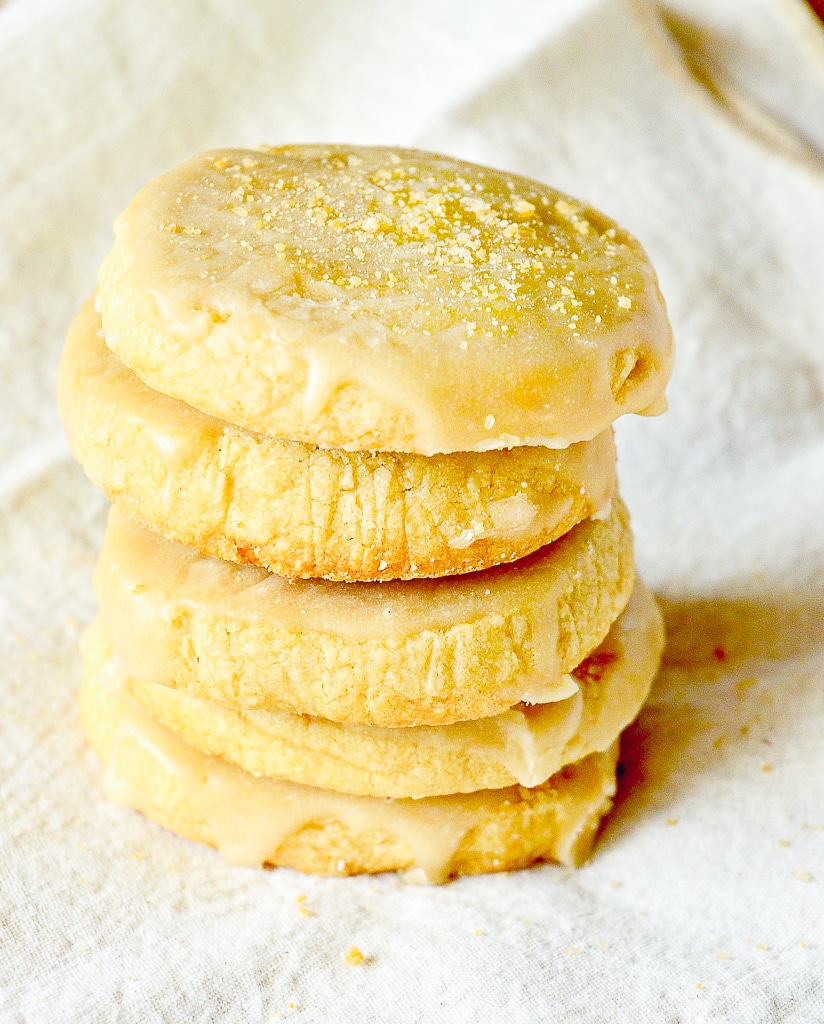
[93,581,663,798]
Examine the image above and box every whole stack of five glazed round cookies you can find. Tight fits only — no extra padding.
[58,146,671,881]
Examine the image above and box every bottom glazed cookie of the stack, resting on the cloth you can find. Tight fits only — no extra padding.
[80,663,617,882]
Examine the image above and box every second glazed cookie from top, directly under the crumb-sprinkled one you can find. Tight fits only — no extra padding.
[57,302,615,581]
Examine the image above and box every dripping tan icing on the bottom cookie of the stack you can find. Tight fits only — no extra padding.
[81,666,615,883]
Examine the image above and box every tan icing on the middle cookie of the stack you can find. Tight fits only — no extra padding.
[95,505,632,725]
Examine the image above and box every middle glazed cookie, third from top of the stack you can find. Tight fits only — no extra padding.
[95,500,635,726]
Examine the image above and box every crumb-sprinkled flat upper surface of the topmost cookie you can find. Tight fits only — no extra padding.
[151,146,646,347]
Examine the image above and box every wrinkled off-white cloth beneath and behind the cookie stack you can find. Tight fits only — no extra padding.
[0,0,824,1024]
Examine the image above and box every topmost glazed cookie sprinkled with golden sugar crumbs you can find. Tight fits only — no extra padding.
[98,145,673,455]
